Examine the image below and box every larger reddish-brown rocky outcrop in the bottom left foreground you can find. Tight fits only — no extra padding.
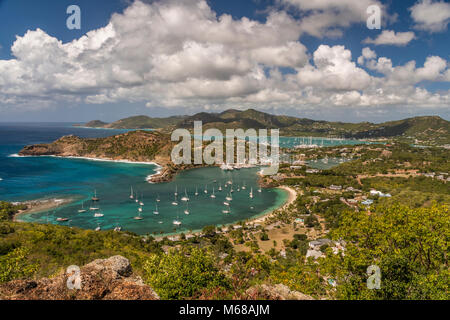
[0,256,159,300]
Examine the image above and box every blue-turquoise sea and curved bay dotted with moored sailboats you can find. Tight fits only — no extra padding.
[0,124,287,234]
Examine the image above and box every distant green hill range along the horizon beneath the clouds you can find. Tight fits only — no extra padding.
[76,109,450,145]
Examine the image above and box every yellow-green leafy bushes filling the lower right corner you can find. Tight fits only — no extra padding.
[323,206,450,299]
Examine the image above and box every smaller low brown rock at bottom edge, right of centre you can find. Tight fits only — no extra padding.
[245,284,314,300]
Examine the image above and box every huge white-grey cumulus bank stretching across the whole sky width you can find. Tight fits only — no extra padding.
[0,0,450,114]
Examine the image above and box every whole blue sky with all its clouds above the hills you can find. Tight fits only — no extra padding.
[0,0,450,122]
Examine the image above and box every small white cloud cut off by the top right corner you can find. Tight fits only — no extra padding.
[409,0,450,32]
